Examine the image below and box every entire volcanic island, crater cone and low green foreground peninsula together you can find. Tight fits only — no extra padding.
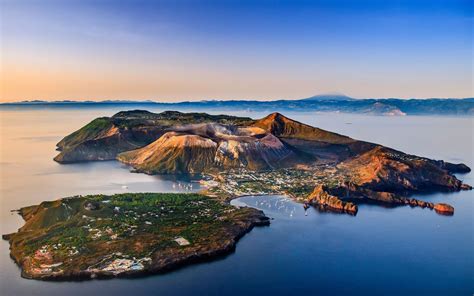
[4,110,472,280]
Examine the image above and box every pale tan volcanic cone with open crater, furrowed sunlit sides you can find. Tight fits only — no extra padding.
[118,123,298,174]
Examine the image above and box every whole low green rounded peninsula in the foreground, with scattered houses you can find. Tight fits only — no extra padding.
[3,193,269,280]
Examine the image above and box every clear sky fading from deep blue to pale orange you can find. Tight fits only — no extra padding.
[0,0,474,102]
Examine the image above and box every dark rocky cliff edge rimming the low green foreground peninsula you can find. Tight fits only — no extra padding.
[2,193,270,281]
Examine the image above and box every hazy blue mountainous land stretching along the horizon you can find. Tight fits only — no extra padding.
[0,94,474,116]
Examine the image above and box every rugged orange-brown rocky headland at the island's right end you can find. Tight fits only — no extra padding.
[308,146,472,215]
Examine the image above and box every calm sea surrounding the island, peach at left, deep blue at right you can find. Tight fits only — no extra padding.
[0,109,474,296]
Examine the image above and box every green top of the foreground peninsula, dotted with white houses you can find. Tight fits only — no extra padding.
[18,193,241,275]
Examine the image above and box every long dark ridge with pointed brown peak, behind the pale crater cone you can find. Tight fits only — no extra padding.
[55,110,373,164]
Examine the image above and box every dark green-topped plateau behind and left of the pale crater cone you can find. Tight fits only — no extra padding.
[54,110,252,163]
